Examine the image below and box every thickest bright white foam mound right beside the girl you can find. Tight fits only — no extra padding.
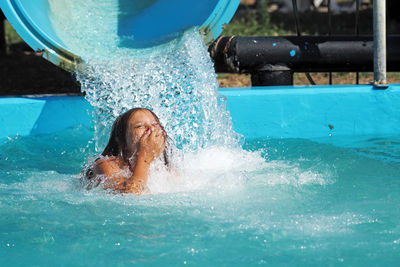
[148,146,265,193]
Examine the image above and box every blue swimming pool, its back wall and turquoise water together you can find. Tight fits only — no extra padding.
[0,85,400,266]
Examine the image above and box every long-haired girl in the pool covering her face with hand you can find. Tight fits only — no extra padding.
[85,108,169,195]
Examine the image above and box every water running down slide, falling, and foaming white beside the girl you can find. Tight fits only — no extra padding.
[50,0,332,193]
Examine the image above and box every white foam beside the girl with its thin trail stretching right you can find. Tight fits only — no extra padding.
[149,146,334,194]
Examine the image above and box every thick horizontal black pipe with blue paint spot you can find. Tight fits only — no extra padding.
[209,35,400,73]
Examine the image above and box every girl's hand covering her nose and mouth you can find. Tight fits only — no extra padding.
[138,125,166,164]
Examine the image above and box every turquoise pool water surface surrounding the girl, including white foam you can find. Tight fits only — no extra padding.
[0,127,400,266]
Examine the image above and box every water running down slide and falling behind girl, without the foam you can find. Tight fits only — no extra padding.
[50,0,239,151]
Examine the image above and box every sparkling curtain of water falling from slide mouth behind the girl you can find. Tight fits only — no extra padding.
[77,29,239,151]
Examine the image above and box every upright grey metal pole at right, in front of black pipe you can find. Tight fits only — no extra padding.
[373,0,387,87]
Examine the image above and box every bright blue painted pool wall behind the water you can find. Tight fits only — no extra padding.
[0,84,400,143]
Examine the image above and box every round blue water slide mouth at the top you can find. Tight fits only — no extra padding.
[0,0,240,70]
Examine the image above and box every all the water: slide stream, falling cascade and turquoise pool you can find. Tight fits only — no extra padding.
[5,3,400,266]
